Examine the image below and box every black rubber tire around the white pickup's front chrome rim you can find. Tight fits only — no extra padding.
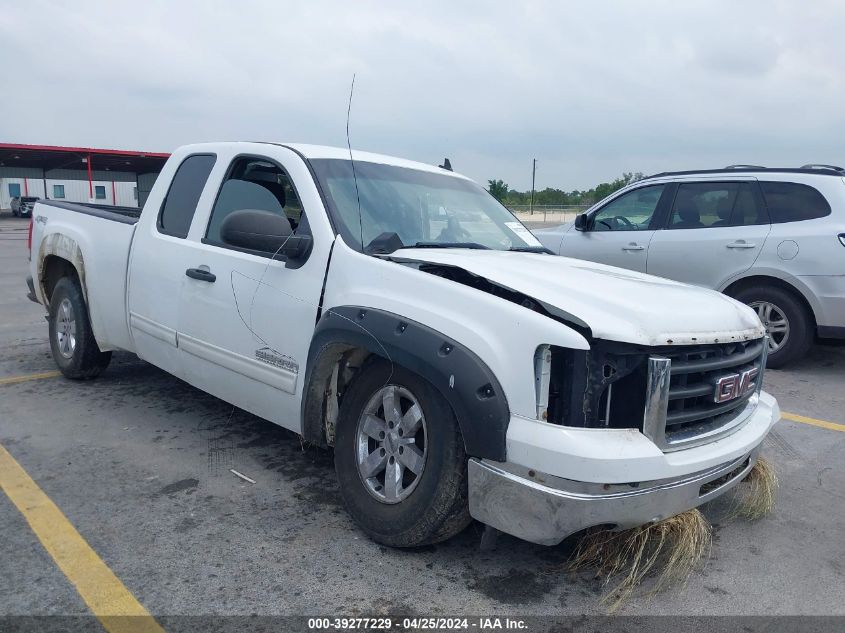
[334,359,472,547]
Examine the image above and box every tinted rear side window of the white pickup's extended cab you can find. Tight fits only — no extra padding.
[158,154,216,237]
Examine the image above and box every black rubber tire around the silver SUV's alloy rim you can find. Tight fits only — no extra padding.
[734,286,815,369]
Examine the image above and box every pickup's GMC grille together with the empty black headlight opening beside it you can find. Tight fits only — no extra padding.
[536,339,767,452]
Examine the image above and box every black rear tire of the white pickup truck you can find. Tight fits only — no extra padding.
[48,277,111,380]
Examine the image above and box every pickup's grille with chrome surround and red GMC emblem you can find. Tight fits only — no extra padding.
[643,339,767,451]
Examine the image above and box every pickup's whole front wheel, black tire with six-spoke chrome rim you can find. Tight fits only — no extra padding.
[335,360,471,547]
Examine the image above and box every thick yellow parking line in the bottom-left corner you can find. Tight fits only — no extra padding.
[0,446,164,633]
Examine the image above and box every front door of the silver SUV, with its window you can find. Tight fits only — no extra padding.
[560,184,669,273]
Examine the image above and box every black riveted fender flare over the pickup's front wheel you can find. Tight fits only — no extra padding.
[302,306,510,461]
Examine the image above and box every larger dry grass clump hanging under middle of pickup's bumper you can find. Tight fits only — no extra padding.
[570,509,712,613]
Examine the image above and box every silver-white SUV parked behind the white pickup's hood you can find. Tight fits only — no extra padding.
[535,165,845,367]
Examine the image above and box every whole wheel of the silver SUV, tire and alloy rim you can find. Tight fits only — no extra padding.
[734,286,813,369]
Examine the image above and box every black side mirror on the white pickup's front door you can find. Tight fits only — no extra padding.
[220,209,311,260]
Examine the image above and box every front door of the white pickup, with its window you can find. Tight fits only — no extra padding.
[179,148,331,431]
